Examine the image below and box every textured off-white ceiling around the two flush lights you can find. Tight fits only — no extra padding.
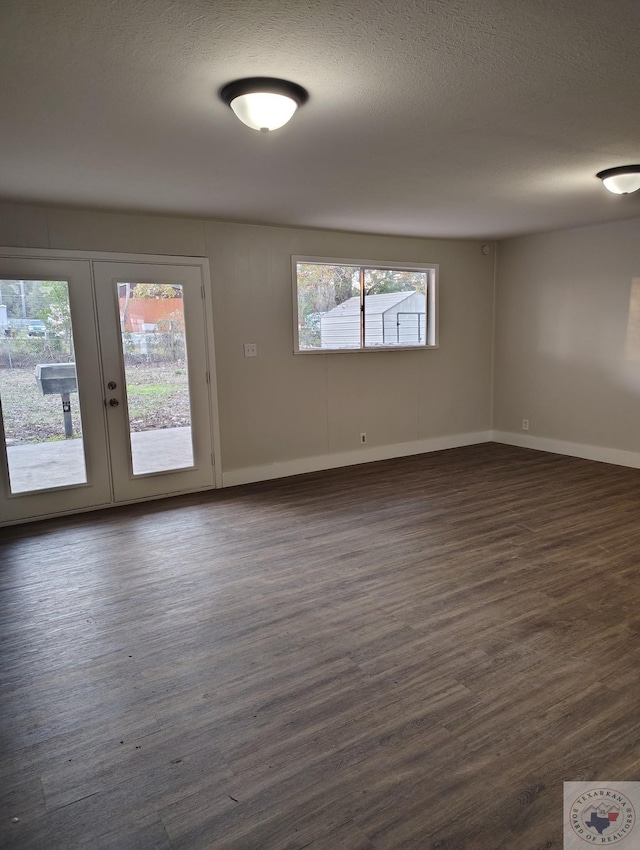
[0,0,640,238]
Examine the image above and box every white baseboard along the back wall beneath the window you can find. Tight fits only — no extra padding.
[222,431,492,487]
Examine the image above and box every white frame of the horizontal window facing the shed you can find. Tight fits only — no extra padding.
[291,254,440,354]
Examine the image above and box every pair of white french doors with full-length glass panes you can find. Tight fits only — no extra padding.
[0,252,217,524]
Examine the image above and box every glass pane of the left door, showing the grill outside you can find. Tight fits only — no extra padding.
[0,280,87,493]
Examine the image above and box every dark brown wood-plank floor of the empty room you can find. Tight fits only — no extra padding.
[0,444,640,850]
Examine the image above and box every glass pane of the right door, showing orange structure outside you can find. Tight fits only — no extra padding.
[116,281,193,475]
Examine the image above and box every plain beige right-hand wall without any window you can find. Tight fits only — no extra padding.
[494,215,640,466]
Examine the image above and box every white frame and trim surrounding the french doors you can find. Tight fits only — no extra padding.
[0,247,222,527]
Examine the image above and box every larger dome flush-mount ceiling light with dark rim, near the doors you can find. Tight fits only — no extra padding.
[220,77,309,133]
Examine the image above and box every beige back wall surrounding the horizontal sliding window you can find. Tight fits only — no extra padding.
[0,204,494,476]
